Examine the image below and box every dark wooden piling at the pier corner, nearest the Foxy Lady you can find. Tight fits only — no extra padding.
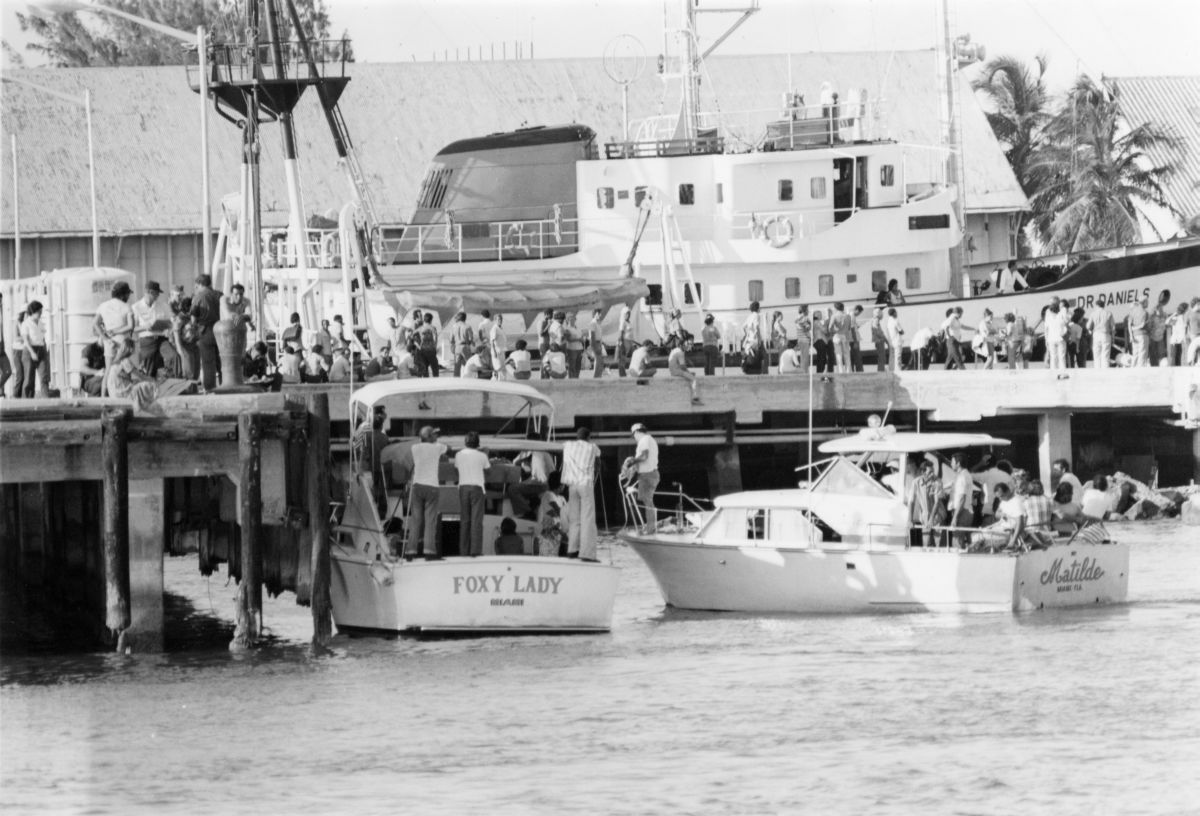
[305,394,334,649]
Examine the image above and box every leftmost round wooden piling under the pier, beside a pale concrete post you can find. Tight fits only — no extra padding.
[100,408,130,652]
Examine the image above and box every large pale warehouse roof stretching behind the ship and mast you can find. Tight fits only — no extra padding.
[0,50,1025,235]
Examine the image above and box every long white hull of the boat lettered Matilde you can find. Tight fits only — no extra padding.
[620,533,1129,613]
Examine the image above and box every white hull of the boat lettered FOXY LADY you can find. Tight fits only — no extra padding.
[330,547,619,634]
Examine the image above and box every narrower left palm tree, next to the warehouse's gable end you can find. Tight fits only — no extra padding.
[972,54,1050,258]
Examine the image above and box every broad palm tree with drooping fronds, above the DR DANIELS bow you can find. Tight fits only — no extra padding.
[1030,76,1178,252]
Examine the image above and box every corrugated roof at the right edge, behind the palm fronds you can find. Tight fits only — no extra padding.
[1109,76,1200,218]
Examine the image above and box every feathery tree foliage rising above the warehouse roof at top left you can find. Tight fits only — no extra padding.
[5,0,354,67]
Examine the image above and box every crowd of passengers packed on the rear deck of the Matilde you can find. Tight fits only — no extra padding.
[902,452,1122,551]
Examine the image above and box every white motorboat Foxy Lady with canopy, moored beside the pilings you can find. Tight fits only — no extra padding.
[331,378,619,634]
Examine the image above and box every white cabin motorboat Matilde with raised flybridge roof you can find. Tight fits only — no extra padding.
[619,428,1129,613]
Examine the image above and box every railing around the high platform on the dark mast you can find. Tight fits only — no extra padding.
[187,40,350,90]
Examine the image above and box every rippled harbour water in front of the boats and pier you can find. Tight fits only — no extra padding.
[0,522,1200,816]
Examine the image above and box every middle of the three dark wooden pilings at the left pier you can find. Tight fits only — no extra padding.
[229,412,263,650]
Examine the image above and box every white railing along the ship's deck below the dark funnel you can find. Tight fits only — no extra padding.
[377,218,580,264]
